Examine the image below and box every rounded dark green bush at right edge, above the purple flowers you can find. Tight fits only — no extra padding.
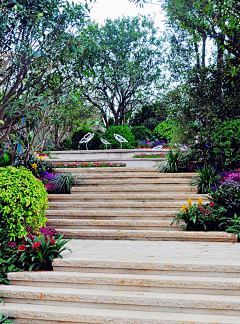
[211,119,240,166]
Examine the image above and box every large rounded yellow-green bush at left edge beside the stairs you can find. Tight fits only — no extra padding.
[0,166,47,241]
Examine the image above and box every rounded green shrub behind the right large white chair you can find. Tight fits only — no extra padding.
[101,126,136,149]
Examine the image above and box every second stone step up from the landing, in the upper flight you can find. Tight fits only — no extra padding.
[47,219,179,231]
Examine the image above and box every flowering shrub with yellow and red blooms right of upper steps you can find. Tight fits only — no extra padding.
[172,198,226,231]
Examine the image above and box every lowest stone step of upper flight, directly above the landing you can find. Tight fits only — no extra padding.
[54,228,238,242]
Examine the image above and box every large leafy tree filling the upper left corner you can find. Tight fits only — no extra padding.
[0,0,94,144]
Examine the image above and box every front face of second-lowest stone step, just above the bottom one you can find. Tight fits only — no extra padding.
[4,294,240,316]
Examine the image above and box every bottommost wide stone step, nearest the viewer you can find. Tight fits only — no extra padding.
[0,303,239,324]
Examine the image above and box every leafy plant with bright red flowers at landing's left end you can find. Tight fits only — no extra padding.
[19,235,71,271]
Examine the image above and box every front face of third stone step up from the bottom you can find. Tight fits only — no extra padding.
[10,278,240,296]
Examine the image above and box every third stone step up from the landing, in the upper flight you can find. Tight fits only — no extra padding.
[46,208,176,220]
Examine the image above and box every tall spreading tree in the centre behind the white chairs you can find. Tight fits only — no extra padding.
[78,17,163,127]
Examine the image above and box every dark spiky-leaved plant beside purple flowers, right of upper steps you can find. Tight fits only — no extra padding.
[190,165,221,194]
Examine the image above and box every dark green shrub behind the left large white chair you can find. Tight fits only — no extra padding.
[71,127,103,150]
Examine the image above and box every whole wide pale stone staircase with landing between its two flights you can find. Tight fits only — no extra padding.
[0,168,240,324]
